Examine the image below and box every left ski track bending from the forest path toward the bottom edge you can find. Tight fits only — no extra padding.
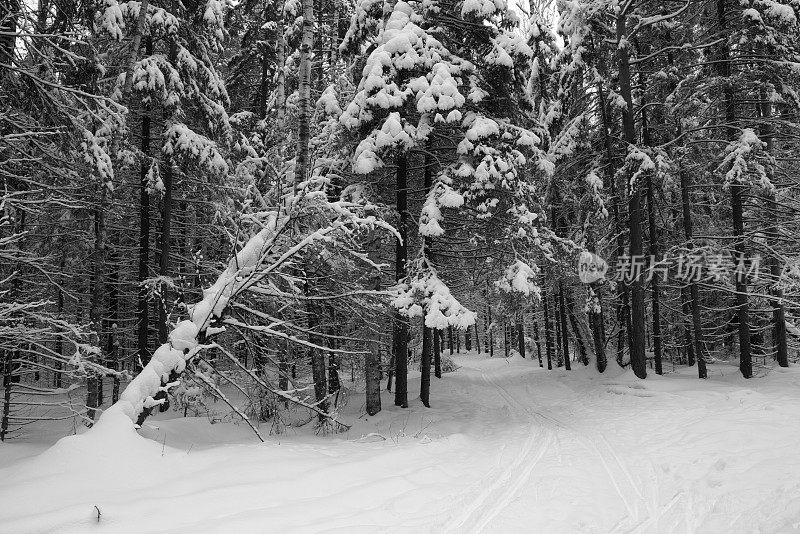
[444,371,560,532]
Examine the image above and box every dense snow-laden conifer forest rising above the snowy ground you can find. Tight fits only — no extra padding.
[0,0,800,439]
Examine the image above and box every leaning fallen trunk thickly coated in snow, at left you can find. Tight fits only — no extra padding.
[95,214,279,432]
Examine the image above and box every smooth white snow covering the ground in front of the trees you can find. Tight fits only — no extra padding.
[0,354,800,533]
